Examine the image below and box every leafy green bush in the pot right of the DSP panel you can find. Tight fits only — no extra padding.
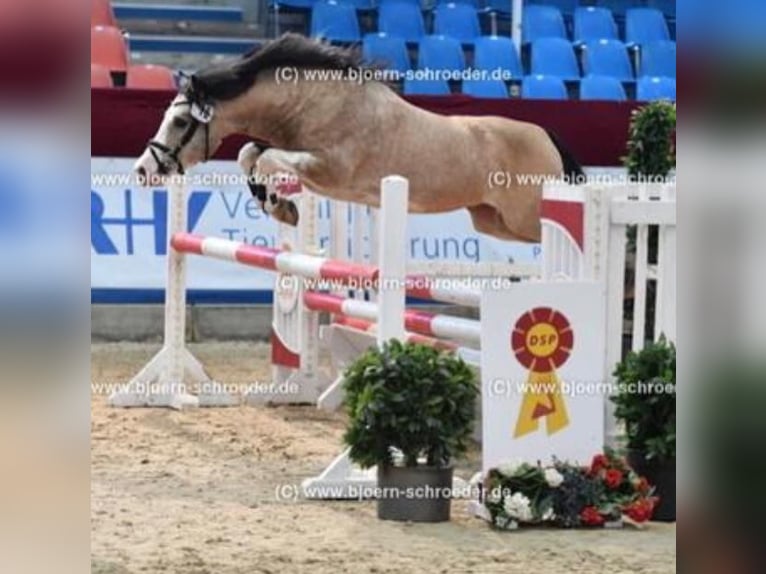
[611,337,676,462]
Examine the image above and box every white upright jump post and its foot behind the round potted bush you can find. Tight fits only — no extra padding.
[302,175,409,499]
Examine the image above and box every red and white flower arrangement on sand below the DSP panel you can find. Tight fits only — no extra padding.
[484,450,657,529]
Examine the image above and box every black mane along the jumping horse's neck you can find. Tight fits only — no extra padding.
[185,33,362,101]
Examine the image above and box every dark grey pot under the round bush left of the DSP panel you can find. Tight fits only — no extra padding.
[378,465,453,522]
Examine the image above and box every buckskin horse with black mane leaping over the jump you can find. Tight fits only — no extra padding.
[135,34,582,242]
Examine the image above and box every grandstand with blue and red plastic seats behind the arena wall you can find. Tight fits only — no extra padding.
[91,0,676,100]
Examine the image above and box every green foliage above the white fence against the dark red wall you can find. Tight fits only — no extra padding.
[623,101,676,178]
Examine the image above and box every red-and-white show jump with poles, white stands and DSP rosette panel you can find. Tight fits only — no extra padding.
[110,176,676,498]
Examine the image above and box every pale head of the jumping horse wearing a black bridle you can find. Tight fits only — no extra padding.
[134,76,228,185]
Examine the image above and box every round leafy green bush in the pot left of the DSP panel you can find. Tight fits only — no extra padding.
[344,340,479,468]
